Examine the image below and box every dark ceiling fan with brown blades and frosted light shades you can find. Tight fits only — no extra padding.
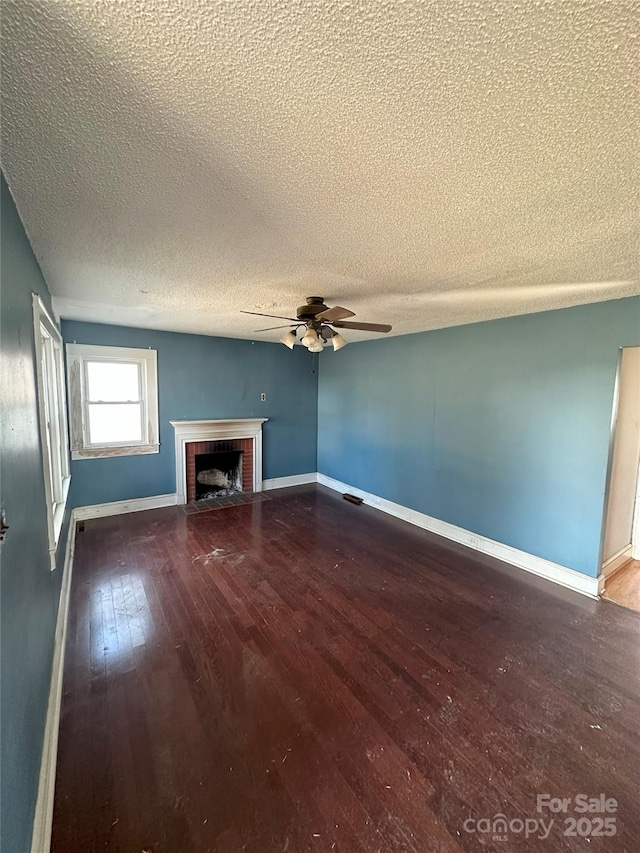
[242,296,391,352]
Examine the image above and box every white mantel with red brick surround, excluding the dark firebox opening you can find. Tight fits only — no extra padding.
[171,418,267,504]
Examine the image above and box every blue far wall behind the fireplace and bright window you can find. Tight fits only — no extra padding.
[62,320,318,506]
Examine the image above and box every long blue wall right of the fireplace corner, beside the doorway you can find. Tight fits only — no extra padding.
[318,297,640,576]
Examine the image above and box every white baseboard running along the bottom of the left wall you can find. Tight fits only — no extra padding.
[31,510,76,853]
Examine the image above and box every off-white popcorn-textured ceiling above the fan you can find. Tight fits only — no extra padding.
[2,0,640,340]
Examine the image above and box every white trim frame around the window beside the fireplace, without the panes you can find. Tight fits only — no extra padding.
[67,344,160,460]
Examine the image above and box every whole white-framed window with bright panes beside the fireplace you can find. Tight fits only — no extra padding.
[67,344,159,459]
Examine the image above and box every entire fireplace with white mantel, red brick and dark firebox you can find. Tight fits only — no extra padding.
[171,418,266,504]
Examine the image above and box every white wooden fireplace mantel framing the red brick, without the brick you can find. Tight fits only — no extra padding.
[171,418,269,504]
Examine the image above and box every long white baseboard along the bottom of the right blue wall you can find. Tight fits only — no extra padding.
[318,473,599,598]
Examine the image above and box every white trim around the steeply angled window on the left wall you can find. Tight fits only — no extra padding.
[32,293,71,571]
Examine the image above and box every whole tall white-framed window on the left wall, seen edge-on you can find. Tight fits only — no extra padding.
[33,293,71,569]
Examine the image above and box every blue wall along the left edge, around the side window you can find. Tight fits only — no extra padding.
[0,175,68,853]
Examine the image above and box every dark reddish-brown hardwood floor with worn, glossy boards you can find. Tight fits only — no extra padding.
[52,486,640,853]
